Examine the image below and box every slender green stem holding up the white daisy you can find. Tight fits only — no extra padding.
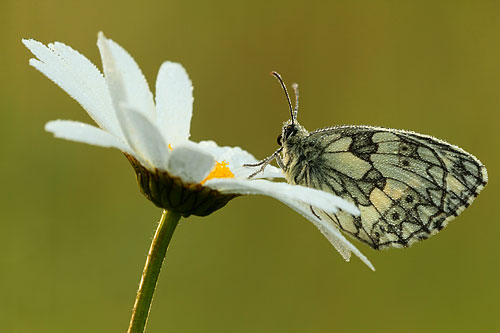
[127,210,181,333]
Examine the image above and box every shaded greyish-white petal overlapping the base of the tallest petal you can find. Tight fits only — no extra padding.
[119,104,170,170]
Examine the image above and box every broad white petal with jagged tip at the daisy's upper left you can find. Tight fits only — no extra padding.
[23,39,121,136]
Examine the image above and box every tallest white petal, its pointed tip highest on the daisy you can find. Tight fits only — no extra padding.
[97,32,156,120]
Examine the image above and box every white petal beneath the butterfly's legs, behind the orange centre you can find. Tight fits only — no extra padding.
[198,141,284,179]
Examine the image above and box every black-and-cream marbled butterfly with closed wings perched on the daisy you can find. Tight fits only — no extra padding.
[248,72,488,249]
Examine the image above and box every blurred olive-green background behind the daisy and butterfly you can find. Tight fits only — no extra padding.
[0,0,500,332]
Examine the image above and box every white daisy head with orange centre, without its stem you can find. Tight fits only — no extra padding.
[23,33,374,269]
